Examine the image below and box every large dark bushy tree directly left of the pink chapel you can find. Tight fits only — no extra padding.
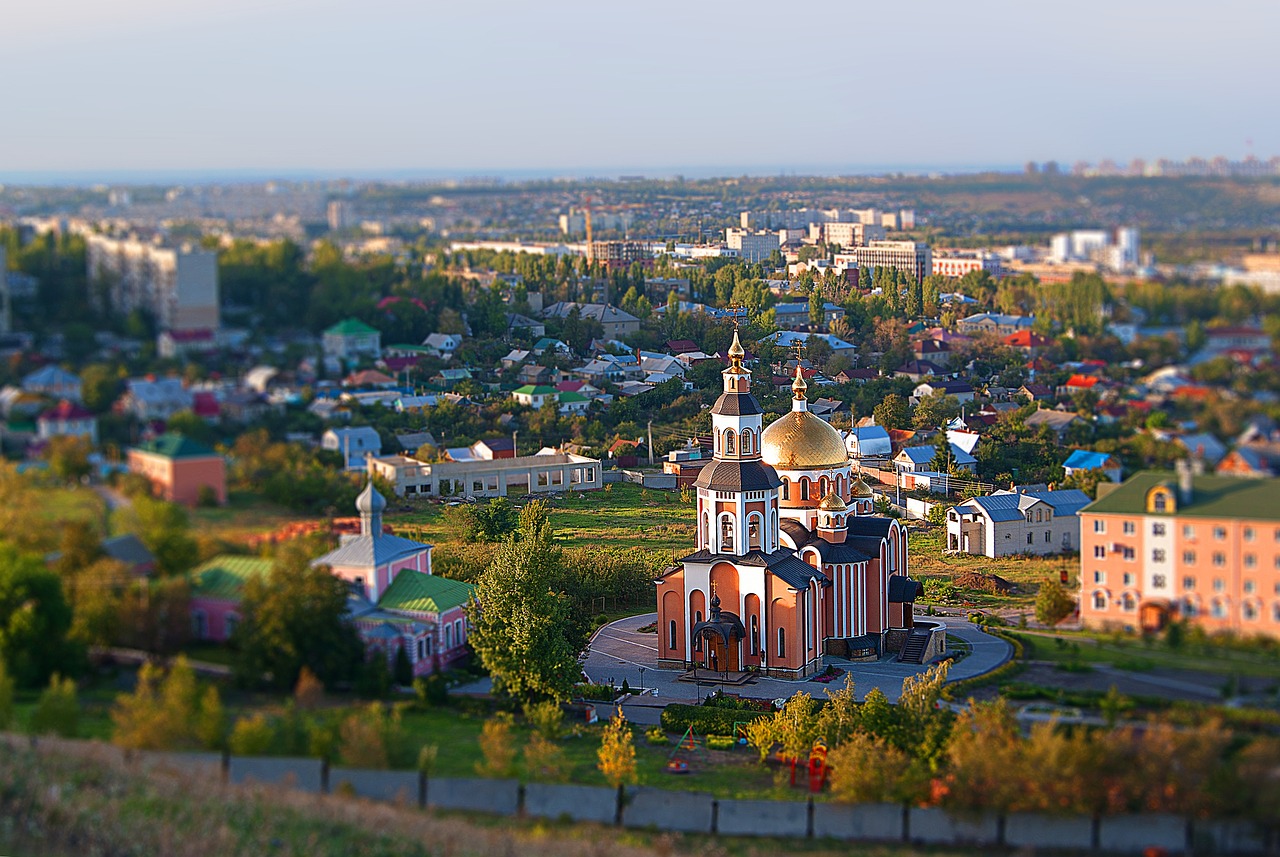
[232,544,364,689]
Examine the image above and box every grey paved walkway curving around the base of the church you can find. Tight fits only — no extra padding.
[582,613,1014,723]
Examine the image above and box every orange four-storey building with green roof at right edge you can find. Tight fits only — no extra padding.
[1080,460,1280,637]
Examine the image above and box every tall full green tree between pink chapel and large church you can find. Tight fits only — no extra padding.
[467,503,585,701]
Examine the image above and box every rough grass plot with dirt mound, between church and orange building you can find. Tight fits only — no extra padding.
[910,527,1079,613]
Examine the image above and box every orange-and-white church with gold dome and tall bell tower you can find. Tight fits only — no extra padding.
[658,333,922,678]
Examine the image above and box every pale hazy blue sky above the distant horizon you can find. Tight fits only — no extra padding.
[0,0,1280,175]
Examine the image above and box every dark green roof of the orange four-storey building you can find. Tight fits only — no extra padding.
[1080,471,1280,521]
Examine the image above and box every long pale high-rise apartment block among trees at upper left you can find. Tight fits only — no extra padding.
[86,234,220,330]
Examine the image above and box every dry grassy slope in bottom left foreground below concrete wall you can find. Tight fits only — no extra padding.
[0,744,963,857]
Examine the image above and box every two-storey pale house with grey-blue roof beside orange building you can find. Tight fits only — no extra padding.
[946,489,1089,558]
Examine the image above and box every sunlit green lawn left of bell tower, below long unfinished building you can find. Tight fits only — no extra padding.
[387,482,694,553]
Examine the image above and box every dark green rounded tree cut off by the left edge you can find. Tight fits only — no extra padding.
[0,545,83,687]
